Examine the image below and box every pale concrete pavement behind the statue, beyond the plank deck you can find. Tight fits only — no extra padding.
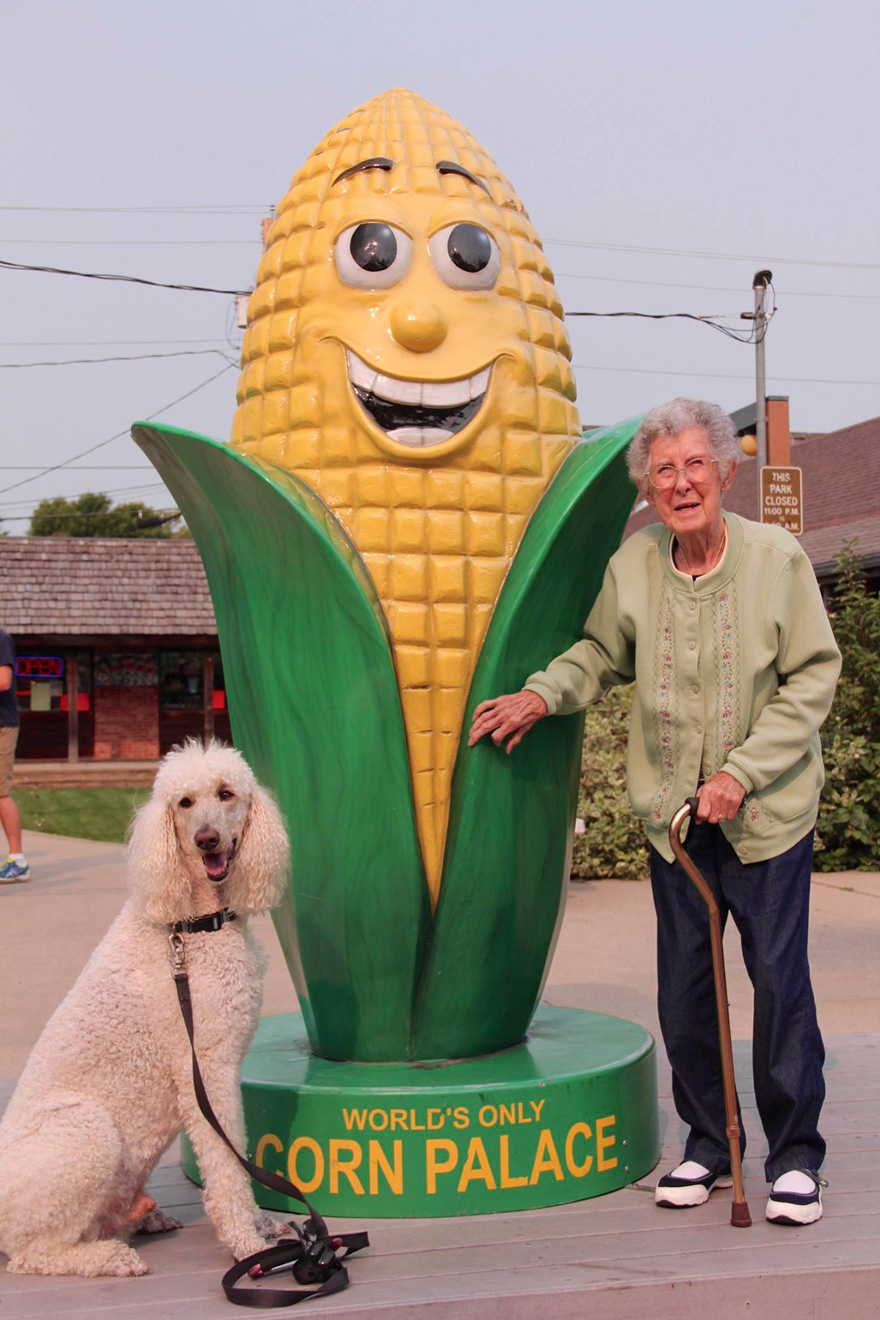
[0,832,880,1077]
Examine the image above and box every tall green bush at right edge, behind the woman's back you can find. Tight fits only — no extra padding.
[815,543,880,871]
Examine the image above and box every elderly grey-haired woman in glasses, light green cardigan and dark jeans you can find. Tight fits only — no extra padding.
[470,399,840,1225]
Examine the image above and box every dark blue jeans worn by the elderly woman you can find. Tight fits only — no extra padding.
[650,824,825,1181]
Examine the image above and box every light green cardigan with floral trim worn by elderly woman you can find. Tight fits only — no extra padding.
[525,513,840,862]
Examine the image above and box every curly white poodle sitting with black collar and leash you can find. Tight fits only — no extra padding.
[0,742,289,1276]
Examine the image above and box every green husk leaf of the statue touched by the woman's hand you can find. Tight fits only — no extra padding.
[413,418,639,1059]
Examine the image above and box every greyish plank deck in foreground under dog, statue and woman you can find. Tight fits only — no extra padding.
[0,1032,880,1320]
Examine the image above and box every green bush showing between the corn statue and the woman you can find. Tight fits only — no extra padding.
[571,688,648,880]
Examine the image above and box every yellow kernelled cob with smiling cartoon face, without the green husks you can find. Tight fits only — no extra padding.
[232,90,581,903]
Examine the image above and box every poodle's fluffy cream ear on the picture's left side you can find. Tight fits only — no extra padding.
[127,797,191,925]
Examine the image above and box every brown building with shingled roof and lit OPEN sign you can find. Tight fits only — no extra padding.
[0,536,231,760]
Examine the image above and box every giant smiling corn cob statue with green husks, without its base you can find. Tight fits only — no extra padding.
[135,90,641,1059]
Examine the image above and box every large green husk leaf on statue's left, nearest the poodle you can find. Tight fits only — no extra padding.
[132,424,430,1060]
